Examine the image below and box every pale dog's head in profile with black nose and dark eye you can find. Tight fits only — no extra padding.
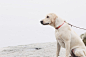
[40,13,58,25]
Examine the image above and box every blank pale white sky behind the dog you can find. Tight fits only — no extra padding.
[0,0,86,47]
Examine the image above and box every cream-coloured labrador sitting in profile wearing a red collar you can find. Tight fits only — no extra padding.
[40,13,86,57]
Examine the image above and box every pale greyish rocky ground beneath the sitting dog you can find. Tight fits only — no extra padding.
[0,42,65,57]
